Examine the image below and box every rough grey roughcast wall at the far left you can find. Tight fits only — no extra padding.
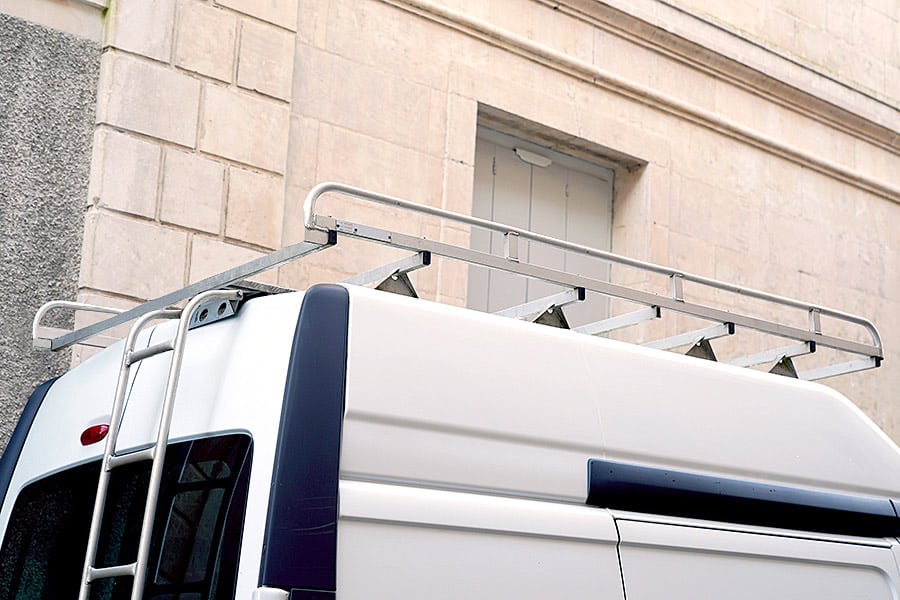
[0,14,100,447]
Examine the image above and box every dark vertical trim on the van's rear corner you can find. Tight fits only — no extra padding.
[259,284,350,598]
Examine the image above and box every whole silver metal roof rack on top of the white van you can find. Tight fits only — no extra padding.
[34,183,884,380]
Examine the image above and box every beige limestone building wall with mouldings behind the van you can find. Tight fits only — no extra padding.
[3,0,900,439]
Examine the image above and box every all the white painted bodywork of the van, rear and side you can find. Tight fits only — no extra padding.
[7,286,900,600]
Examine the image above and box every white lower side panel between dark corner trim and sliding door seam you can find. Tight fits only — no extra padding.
[338,481,624,600]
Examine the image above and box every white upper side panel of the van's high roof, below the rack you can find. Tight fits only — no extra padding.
[342,289,900,502]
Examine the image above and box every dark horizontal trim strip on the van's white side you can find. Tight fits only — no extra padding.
[587,459,900,537]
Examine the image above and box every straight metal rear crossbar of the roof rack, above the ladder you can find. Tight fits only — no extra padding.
[50,232,336,350]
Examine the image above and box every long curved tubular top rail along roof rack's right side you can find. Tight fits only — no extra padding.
[303,182,883,357]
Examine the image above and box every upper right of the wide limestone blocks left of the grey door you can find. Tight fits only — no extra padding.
[200,84,290,173]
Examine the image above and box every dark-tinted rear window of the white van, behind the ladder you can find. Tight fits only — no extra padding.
[0,435,251,600]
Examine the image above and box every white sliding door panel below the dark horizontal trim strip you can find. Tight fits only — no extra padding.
[617,520,898,600]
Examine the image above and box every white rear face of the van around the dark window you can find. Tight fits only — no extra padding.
[0,294,302,598]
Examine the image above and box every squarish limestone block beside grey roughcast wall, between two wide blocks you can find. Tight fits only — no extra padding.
[88,127,162,218]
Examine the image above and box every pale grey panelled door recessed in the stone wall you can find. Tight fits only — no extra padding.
[468,129,613,326]
